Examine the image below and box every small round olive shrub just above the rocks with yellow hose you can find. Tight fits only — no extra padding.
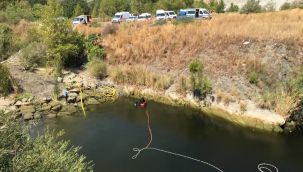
[86,59,107,78]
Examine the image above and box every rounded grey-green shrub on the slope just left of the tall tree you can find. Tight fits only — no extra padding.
[21,42,46,71]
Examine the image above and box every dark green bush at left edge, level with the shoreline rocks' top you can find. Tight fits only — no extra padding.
[0,63,12,96]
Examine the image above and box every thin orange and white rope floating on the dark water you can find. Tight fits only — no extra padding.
[132,111,279,172]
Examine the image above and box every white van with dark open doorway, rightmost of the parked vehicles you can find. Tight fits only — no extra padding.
[180,8,212,19]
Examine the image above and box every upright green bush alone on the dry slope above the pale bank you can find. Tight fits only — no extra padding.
[189,59,212,99]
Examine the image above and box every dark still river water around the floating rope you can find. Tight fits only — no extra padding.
[37,98,303,172]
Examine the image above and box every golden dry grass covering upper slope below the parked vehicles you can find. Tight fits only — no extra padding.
[103,10,303,70]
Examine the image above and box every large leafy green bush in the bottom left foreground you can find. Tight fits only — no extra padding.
[0,113,92,171]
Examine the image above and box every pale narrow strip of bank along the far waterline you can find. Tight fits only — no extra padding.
[118,85,285,132]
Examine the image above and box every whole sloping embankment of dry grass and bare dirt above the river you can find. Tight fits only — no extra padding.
[103,10,303,130]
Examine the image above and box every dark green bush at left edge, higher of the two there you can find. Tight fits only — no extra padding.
[0,23,13,61]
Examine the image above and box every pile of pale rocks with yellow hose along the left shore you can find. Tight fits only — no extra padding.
[2,73,118,121]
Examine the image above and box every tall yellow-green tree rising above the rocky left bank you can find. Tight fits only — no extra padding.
[41,0,85,75]
